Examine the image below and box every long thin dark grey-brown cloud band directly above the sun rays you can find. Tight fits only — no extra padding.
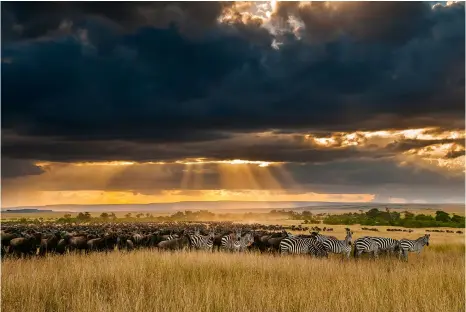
[2,133,376,162]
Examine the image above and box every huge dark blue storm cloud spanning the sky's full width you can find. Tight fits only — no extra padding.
[2,3,464,141]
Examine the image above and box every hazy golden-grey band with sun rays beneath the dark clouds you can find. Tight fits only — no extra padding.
[4,160,464,199]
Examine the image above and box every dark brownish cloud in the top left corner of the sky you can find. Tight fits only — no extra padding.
[2,1,231,41]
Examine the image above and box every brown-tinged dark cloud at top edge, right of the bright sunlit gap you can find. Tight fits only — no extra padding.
[276,1,432,44]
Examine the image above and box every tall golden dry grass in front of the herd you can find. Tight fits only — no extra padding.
[1,244,465,312]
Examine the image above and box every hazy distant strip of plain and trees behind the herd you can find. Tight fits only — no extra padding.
[4,208,465,228]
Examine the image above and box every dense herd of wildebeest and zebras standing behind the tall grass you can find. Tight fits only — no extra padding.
[1,222,442,259]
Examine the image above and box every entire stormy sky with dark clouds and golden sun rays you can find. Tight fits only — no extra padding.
[1,1,465,207]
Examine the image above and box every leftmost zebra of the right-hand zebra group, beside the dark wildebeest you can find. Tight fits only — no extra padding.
[280,235,328,258]
